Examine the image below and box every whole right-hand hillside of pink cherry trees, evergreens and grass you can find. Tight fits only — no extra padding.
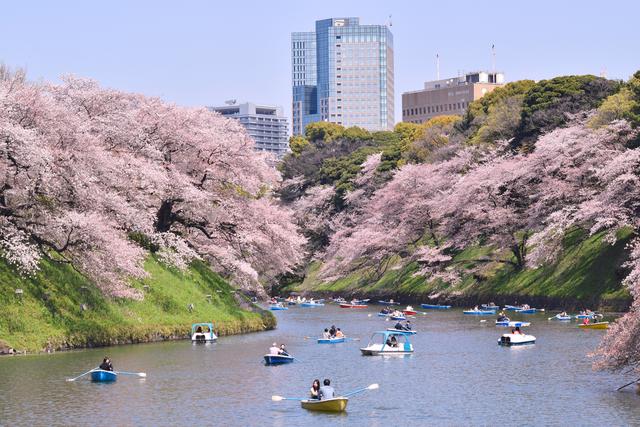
[280,72,640,368]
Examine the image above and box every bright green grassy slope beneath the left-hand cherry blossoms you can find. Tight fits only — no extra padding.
[0,256,275,352]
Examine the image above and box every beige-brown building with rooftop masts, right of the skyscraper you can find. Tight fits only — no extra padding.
[402,71,504,123]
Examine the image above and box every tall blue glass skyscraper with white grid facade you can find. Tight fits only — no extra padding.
[291,18,394,135]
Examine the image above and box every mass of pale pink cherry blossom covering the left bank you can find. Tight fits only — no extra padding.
[0,77,304,297]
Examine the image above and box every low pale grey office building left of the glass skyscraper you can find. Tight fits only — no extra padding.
[209,100,289,157]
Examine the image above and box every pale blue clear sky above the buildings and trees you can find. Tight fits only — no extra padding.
[0,0,640,125]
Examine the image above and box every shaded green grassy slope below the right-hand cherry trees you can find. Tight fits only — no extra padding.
[283,229,631,309]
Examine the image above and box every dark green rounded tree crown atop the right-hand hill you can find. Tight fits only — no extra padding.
[517,75,621,145]
